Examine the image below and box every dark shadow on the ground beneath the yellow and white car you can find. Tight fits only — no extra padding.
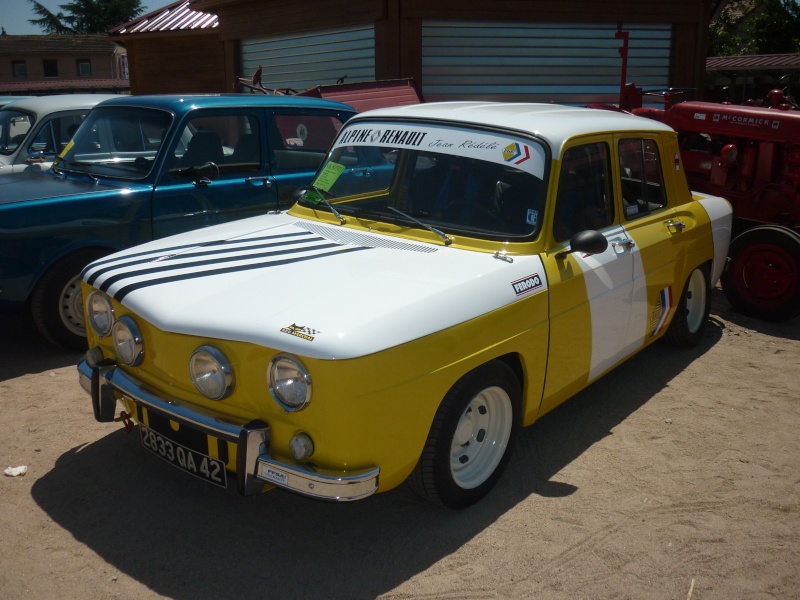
[32,310,723,600]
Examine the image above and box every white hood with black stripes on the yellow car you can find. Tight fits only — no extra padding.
[83,214,547,359]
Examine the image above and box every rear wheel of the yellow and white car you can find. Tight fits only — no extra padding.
[664,265,711,348]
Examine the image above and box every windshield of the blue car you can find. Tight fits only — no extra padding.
[54,106,172,179]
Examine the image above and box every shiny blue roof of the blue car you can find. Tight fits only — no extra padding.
[93,94,355,114]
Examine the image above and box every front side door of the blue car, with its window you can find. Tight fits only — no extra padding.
[153,108,277,238]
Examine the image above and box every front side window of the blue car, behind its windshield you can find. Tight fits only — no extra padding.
[170,114,262,174]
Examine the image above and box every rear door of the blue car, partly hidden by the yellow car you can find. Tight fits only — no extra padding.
[267,108,348,210]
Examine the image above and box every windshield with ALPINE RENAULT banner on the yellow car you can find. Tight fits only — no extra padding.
[301,121,546,239]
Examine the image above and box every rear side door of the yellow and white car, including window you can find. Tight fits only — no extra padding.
[615,134,689,347]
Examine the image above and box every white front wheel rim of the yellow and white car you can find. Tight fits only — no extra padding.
[450,386,514,489]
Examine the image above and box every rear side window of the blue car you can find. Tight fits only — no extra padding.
[270,113,343,173]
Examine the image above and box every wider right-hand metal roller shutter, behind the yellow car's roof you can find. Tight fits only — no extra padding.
[422,21,672,104]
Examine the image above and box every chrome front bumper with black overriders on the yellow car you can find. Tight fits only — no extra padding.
[78,359,380,502]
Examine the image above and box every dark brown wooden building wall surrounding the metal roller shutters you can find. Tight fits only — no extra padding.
[128,0,711,93]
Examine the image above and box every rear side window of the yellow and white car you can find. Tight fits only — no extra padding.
[619,138,667,220]
